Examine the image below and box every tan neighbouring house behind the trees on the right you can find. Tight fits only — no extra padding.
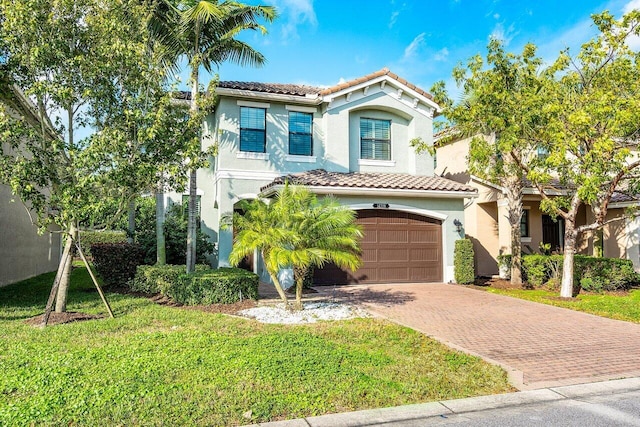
[435,131,640,276]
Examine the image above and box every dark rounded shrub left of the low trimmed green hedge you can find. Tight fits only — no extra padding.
[91,243,144,286]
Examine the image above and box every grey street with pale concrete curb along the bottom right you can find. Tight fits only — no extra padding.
[245,377,640,427]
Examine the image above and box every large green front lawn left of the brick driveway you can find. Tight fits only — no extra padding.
[0,268,511,426]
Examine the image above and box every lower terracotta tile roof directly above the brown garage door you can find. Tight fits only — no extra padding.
[260,169,476,192]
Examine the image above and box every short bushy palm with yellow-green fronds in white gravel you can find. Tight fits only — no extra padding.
[225,184,362,310]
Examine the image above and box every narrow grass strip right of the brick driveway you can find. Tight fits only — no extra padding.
[487,288,640,323]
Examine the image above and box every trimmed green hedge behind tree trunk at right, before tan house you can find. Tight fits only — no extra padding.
[522,255,640,292]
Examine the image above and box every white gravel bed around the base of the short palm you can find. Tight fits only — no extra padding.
[237,302,369,324]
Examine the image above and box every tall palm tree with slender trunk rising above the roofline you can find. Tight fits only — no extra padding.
[151,0,276,273]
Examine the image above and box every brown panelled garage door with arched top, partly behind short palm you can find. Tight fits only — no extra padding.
[314,210,442,284]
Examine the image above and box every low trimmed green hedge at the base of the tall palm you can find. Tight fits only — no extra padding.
[131,265,258,305]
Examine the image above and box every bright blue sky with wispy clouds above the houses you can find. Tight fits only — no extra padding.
[182,0,640,92]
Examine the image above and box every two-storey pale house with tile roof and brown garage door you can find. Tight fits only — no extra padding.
[168,68,476,283]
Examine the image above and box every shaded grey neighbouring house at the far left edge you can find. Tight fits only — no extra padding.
[0,86,60,286]
